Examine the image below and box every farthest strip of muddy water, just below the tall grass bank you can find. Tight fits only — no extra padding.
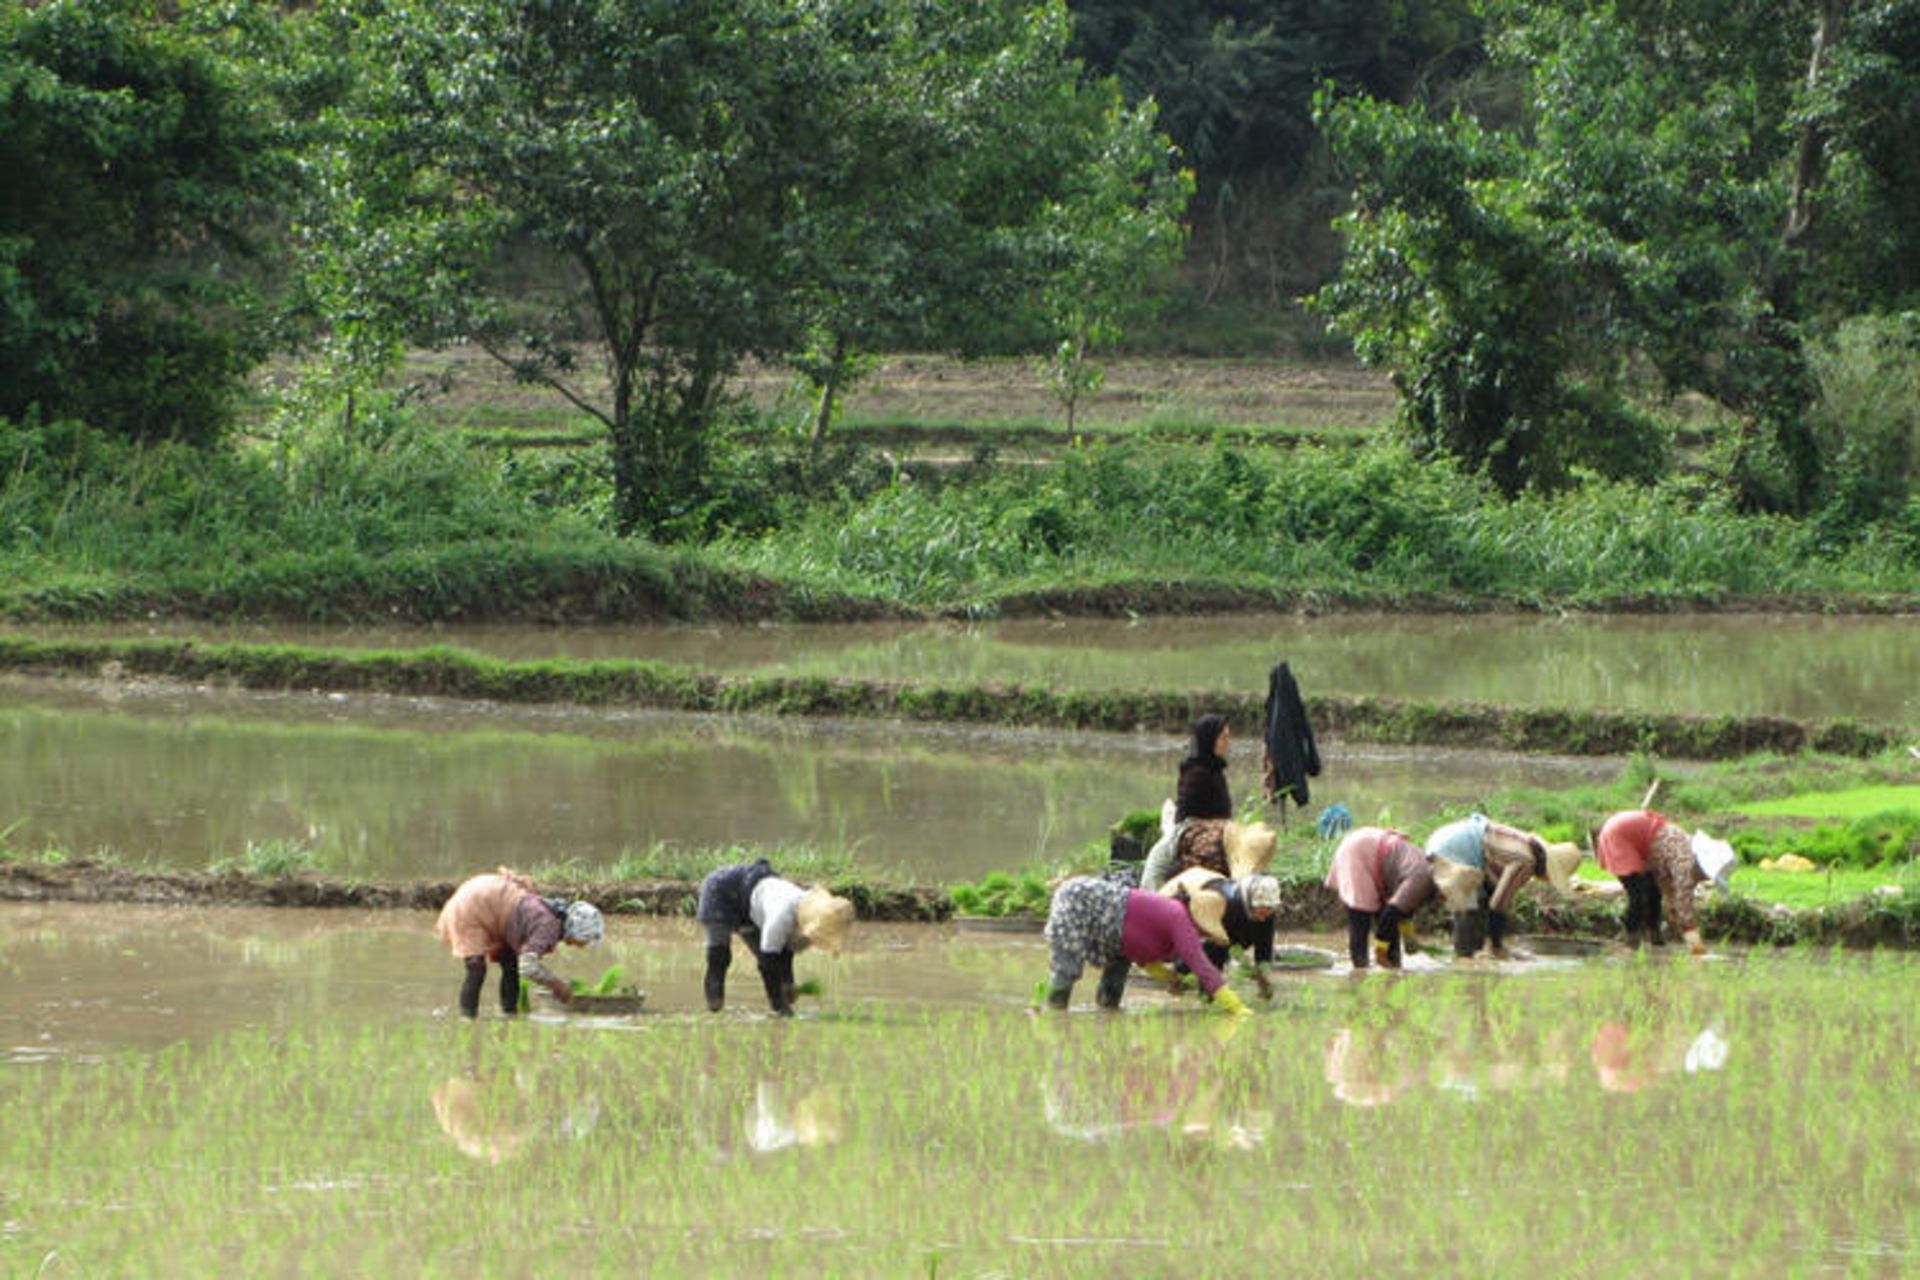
[22,614,1920,723]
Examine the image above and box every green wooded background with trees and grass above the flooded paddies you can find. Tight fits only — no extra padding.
[0,0,1920,620]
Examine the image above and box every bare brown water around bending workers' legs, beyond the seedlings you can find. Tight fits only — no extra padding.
[0,904,1574,1065]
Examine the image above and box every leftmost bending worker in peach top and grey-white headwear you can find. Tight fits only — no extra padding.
[434,867,607,1017]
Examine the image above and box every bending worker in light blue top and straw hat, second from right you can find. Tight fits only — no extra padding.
[1427,814,1582,960]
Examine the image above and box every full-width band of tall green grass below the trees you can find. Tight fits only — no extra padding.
[0,408,1920,620]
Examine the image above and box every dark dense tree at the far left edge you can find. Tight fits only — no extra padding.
[0,0,276,443]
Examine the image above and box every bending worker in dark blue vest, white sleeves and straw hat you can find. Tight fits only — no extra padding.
[693,858,852,1017]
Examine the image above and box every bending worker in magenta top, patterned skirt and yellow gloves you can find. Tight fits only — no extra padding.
[1046,875,1248,1015]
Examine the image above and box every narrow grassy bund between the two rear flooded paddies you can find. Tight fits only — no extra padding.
[0,637,1907,760]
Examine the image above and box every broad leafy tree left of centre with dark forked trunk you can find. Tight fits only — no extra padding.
[338,0,1182,533]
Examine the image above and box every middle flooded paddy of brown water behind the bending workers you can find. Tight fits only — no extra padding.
[0,676,1619,883]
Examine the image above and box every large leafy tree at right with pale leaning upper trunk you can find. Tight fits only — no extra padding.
[1317,0,1914,509]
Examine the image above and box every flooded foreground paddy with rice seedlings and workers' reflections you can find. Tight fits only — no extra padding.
[0,908,1920,1278]
